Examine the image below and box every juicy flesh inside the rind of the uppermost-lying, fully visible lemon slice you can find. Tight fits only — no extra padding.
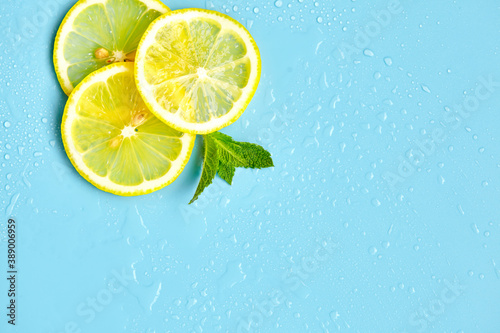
[144,17,251,124]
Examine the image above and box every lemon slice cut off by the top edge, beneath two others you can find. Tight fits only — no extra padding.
[54,0,169,95]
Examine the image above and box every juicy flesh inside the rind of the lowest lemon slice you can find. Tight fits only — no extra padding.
[71,70,183,186]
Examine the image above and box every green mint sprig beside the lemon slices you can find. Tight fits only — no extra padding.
[189,132,274,204]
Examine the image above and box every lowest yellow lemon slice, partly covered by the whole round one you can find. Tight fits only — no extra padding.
[61,63,196,196]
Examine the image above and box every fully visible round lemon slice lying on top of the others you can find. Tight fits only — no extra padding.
[135,9,261,134]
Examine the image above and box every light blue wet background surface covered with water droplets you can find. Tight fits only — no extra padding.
[0,0,500,333]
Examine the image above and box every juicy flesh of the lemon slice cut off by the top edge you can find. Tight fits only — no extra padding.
[63,0,163,87]
